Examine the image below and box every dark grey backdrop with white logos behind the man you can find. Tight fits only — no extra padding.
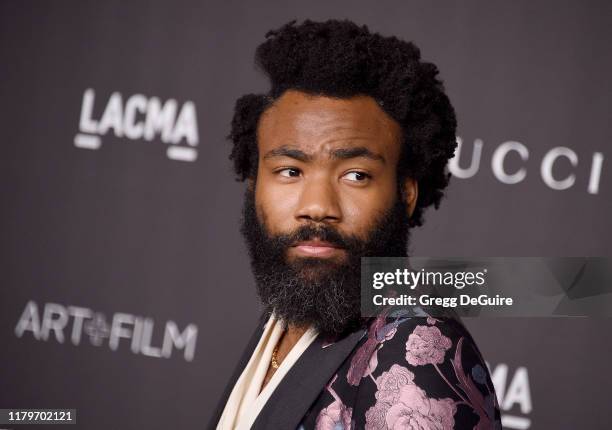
[0,0,612,429]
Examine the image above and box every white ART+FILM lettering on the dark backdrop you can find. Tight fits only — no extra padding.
[15,300,198,361]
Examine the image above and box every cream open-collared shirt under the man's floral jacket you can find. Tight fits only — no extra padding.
[217,314,318,430]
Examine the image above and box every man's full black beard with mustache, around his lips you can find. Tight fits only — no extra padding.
[241,188,409,338]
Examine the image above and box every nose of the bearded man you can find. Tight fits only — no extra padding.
[295,175,341,223]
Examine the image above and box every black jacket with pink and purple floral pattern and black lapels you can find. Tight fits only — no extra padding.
[209,314,501,430]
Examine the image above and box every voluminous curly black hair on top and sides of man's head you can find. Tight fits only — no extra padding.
[229,20,457,226]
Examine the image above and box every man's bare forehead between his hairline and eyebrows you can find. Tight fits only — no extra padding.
[258,90,401,159]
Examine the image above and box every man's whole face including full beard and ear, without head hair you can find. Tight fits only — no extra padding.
[242,91,416,335]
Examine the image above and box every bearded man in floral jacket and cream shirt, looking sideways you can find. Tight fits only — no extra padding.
[210,21,501,429]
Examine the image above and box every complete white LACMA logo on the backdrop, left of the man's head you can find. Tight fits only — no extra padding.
[74,88,199,161]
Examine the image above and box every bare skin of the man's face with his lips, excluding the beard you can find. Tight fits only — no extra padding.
[255,91,401,260]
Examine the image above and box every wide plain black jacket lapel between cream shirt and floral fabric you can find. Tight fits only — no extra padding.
[251,329,365,430]
